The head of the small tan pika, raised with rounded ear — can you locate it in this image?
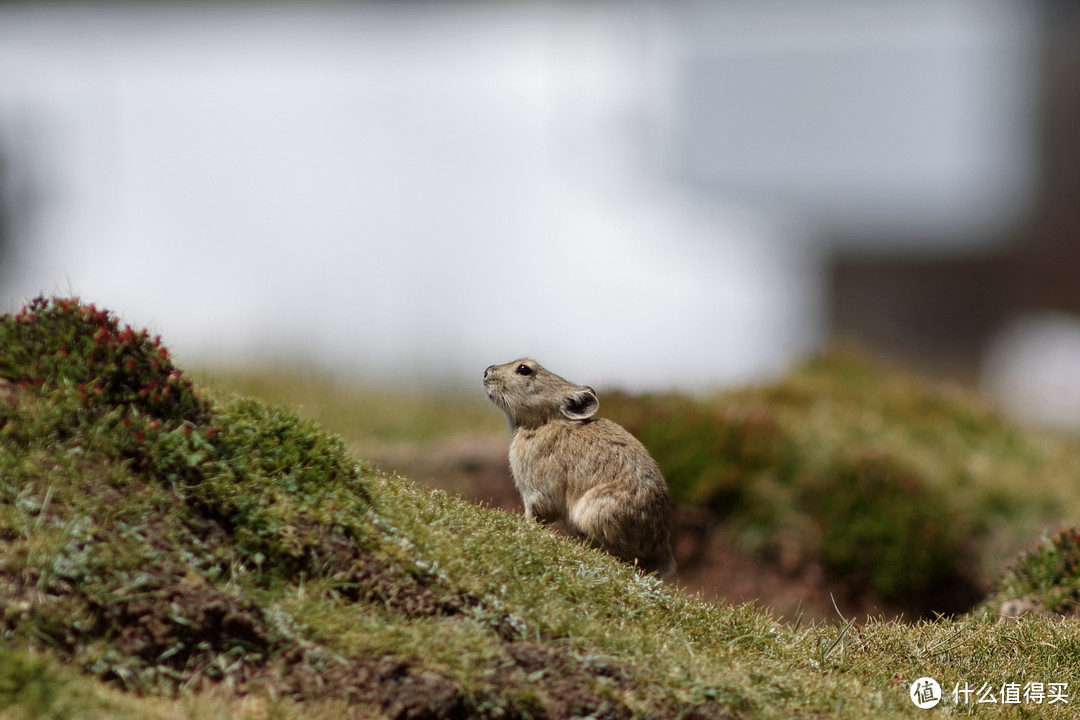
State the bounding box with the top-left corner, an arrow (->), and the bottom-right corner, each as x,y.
484,358 -> 600,429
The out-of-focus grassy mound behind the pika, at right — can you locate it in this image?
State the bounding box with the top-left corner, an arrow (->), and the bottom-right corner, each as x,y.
602,351 -> 1080,614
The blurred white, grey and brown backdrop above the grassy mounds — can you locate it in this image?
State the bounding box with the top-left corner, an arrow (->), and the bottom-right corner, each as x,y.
0,0 -> 1080,426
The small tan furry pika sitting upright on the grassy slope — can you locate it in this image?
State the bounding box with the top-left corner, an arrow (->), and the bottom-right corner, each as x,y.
484,358 -> 675,578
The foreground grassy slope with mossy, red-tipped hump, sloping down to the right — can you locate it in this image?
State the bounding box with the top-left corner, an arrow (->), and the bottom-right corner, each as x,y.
0,300 -> 1080,719
